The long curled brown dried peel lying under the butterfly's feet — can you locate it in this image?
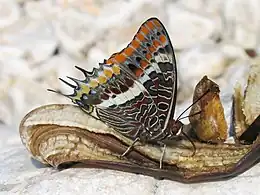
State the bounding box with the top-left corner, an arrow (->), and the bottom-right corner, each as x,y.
20,104 -> 260,183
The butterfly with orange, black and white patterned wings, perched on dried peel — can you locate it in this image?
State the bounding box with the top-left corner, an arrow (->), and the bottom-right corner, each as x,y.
49,18 -> 195,167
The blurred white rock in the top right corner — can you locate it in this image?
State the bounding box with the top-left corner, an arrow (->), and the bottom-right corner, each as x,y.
223,0 -> 260,48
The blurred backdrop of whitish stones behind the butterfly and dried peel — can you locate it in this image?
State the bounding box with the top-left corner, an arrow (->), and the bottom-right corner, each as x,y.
0,0 -> 260,133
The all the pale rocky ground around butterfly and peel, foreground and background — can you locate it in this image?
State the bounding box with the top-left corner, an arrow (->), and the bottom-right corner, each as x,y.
0,0 -> 260,194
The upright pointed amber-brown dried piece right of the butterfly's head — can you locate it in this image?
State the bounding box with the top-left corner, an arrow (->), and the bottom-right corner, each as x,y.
189,76 -> 228,143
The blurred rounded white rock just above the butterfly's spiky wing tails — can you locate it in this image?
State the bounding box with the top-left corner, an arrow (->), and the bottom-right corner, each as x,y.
54,9 -> 104,58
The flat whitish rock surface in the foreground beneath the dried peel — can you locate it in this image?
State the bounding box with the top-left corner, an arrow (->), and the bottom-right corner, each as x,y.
0,136 -> 260,195
